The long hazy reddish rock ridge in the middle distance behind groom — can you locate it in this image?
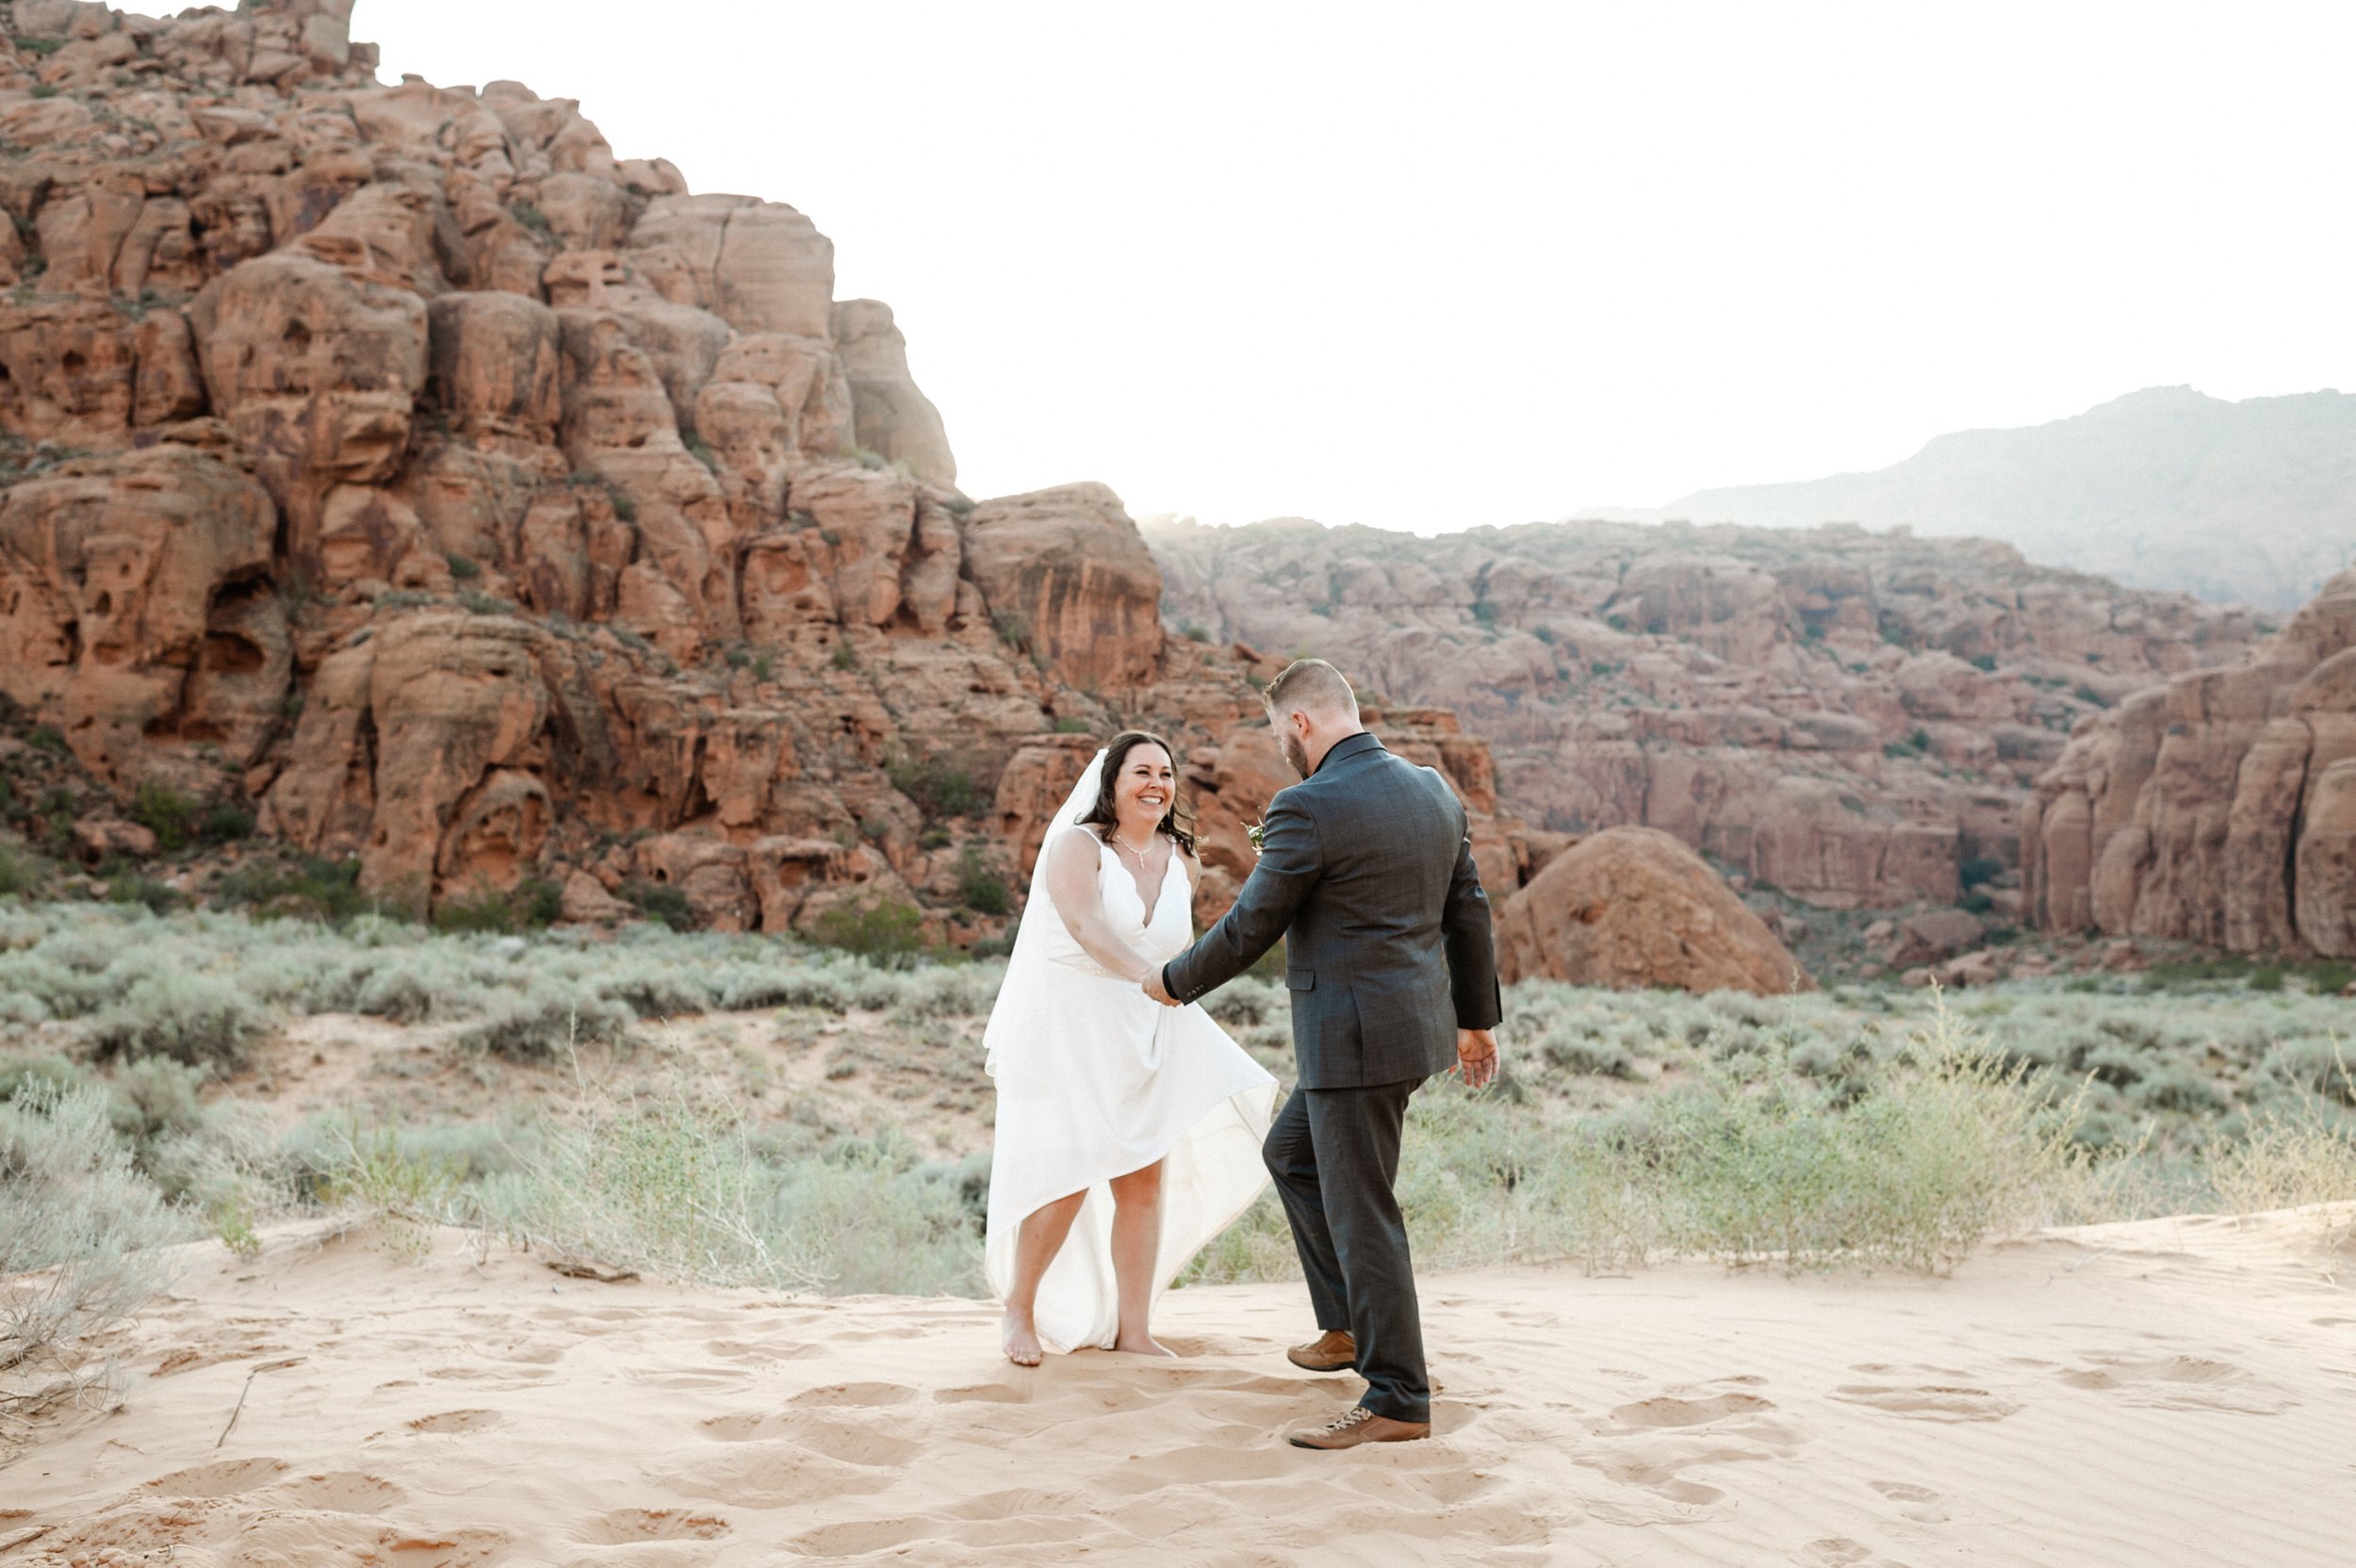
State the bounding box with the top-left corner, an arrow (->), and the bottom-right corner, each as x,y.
1148,506 -> 2252,906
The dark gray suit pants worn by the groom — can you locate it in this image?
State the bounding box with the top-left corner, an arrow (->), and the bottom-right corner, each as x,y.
1261,1078 -> 1432,1422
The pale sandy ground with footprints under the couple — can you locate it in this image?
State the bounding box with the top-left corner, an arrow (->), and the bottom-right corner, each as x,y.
0,1215 -> 2356,1568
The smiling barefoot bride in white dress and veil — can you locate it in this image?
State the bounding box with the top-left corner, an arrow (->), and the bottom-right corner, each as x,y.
983,730 -> 1277,1365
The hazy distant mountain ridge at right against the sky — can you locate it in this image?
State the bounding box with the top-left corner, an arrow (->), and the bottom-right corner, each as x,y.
1579,386 -> 2356,610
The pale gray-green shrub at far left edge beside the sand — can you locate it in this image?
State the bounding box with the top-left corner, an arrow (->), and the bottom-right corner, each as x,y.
0,1086 -> 187,1411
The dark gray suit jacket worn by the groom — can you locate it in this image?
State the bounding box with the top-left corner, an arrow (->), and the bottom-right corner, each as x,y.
1162,735 -> 1503,1087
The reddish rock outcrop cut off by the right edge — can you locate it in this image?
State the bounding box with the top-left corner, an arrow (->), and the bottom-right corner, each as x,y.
2021,572 -> 2356,958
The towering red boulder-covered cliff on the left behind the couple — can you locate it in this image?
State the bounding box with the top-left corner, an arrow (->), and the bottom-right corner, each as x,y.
0,0 -> 1520,939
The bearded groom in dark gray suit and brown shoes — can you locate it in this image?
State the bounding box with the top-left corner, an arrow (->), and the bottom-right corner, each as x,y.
1145,660 -> 1498,1448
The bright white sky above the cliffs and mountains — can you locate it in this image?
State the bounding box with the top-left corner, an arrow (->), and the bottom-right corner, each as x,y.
353,0 -> 2356,532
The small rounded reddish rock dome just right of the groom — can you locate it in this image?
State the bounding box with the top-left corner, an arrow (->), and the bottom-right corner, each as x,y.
1497,826 -> 1812,996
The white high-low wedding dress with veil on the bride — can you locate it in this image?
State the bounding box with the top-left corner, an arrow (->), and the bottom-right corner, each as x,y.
983,754 -> 1277,1351
